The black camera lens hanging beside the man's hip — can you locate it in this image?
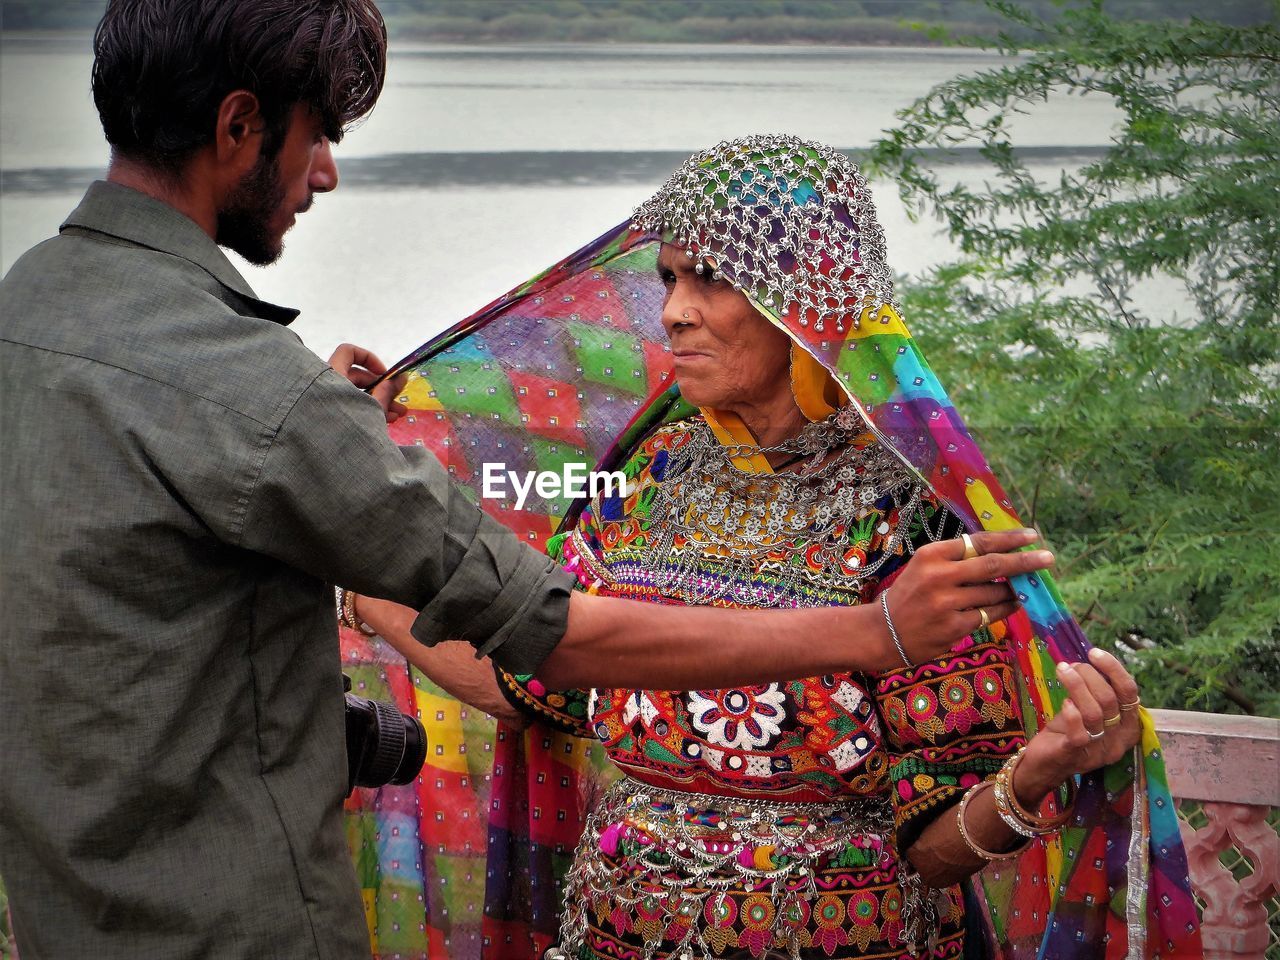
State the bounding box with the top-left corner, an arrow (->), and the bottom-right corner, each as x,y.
342,673 -> 426,794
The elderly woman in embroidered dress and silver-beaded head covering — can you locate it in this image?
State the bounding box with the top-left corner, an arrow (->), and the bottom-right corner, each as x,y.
348,137 -> 1187,960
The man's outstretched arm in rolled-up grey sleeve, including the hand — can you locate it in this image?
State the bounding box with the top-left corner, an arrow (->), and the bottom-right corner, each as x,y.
307,348 -> 1052,690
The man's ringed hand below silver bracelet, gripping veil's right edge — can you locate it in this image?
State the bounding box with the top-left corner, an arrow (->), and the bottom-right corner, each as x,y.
886,529 -> 1053,663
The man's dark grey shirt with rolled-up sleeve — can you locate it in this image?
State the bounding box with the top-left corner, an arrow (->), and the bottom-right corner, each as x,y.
0,183 -> 571,960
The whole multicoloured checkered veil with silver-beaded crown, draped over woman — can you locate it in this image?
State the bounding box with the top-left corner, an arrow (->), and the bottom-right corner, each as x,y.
344,137 -> 1201,960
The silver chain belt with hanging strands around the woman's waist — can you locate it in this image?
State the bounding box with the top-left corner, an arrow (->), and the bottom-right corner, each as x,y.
545,777 -> 932,960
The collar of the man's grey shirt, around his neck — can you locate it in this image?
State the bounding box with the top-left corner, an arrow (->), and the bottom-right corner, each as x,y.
60,180 -> 300,325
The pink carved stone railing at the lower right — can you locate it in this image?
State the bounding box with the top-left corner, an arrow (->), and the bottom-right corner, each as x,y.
1152,710 -> 1280,960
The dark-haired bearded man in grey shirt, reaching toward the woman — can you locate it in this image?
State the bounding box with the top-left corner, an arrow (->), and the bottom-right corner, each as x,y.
0,0 -> 1043,960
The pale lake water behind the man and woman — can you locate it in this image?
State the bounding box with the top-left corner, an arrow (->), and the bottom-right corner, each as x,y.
0,36 -> 1116,361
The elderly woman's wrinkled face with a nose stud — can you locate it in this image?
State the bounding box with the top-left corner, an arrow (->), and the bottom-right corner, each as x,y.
658,243 -> 794,412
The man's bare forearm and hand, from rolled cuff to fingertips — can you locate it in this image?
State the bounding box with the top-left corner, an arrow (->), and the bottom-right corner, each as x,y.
358,530 -> 1053,690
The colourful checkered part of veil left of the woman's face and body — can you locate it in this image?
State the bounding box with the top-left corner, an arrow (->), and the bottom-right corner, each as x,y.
342,224 -> 689,960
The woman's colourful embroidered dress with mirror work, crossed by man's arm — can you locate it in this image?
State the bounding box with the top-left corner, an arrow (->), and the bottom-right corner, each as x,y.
502,416 -> 1023,960
